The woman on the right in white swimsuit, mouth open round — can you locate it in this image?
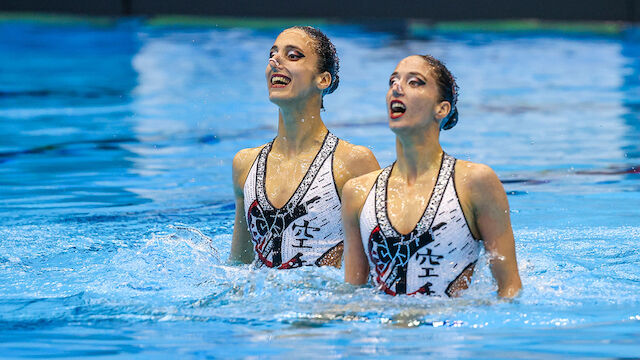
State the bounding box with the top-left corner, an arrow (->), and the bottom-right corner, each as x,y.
343,55 -> 521,297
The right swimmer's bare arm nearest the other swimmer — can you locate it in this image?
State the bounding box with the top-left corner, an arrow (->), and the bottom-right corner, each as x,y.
342,179 -> 369,285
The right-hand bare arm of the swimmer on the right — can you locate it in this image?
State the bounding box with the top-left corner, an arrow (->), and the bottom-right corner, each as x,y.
471,165 -> 522,298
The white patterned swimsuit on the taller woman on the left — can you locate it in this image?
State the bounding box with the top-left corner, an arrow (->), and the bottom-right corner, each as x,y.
244,133 -> 344,269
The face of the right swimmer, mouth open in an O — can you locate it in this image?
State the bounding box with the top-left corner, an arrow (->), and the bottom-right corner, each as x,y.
387,56 -> 451,132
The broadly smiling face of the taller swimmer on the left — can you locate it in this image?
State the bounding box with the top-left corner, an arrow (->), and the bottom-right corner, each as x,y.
265,29 -> 331,106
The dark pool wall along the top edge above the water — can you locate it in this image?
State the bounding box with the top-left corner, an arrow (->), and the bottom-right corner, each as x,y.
0,0 -> 640,22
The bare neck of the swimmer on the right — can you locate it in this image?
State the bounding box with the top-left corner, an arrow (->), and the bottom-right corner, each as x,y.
394,129 -> 442,186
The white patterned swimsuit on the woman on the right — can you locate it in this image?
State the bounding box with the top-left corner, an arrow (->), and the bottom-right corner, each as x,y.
360,154 -> 480,296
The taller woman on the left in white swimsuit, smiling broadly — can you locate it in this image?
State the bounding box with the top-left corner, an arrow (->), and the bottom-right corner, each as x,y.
231,26 -> 380,269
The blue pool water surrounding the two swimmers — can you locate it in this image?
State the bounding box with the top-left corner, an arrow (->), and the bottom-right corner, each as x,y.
0,19 -> 640,359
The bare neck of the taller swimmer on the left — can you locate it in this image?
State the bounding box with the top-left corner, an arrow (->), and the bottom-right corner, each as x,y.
273,106 -> 329,156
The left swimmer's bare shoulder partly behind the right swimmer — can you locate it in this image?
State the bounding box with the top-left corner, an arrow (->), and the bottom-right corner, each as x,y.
334,139 -> 380,182
